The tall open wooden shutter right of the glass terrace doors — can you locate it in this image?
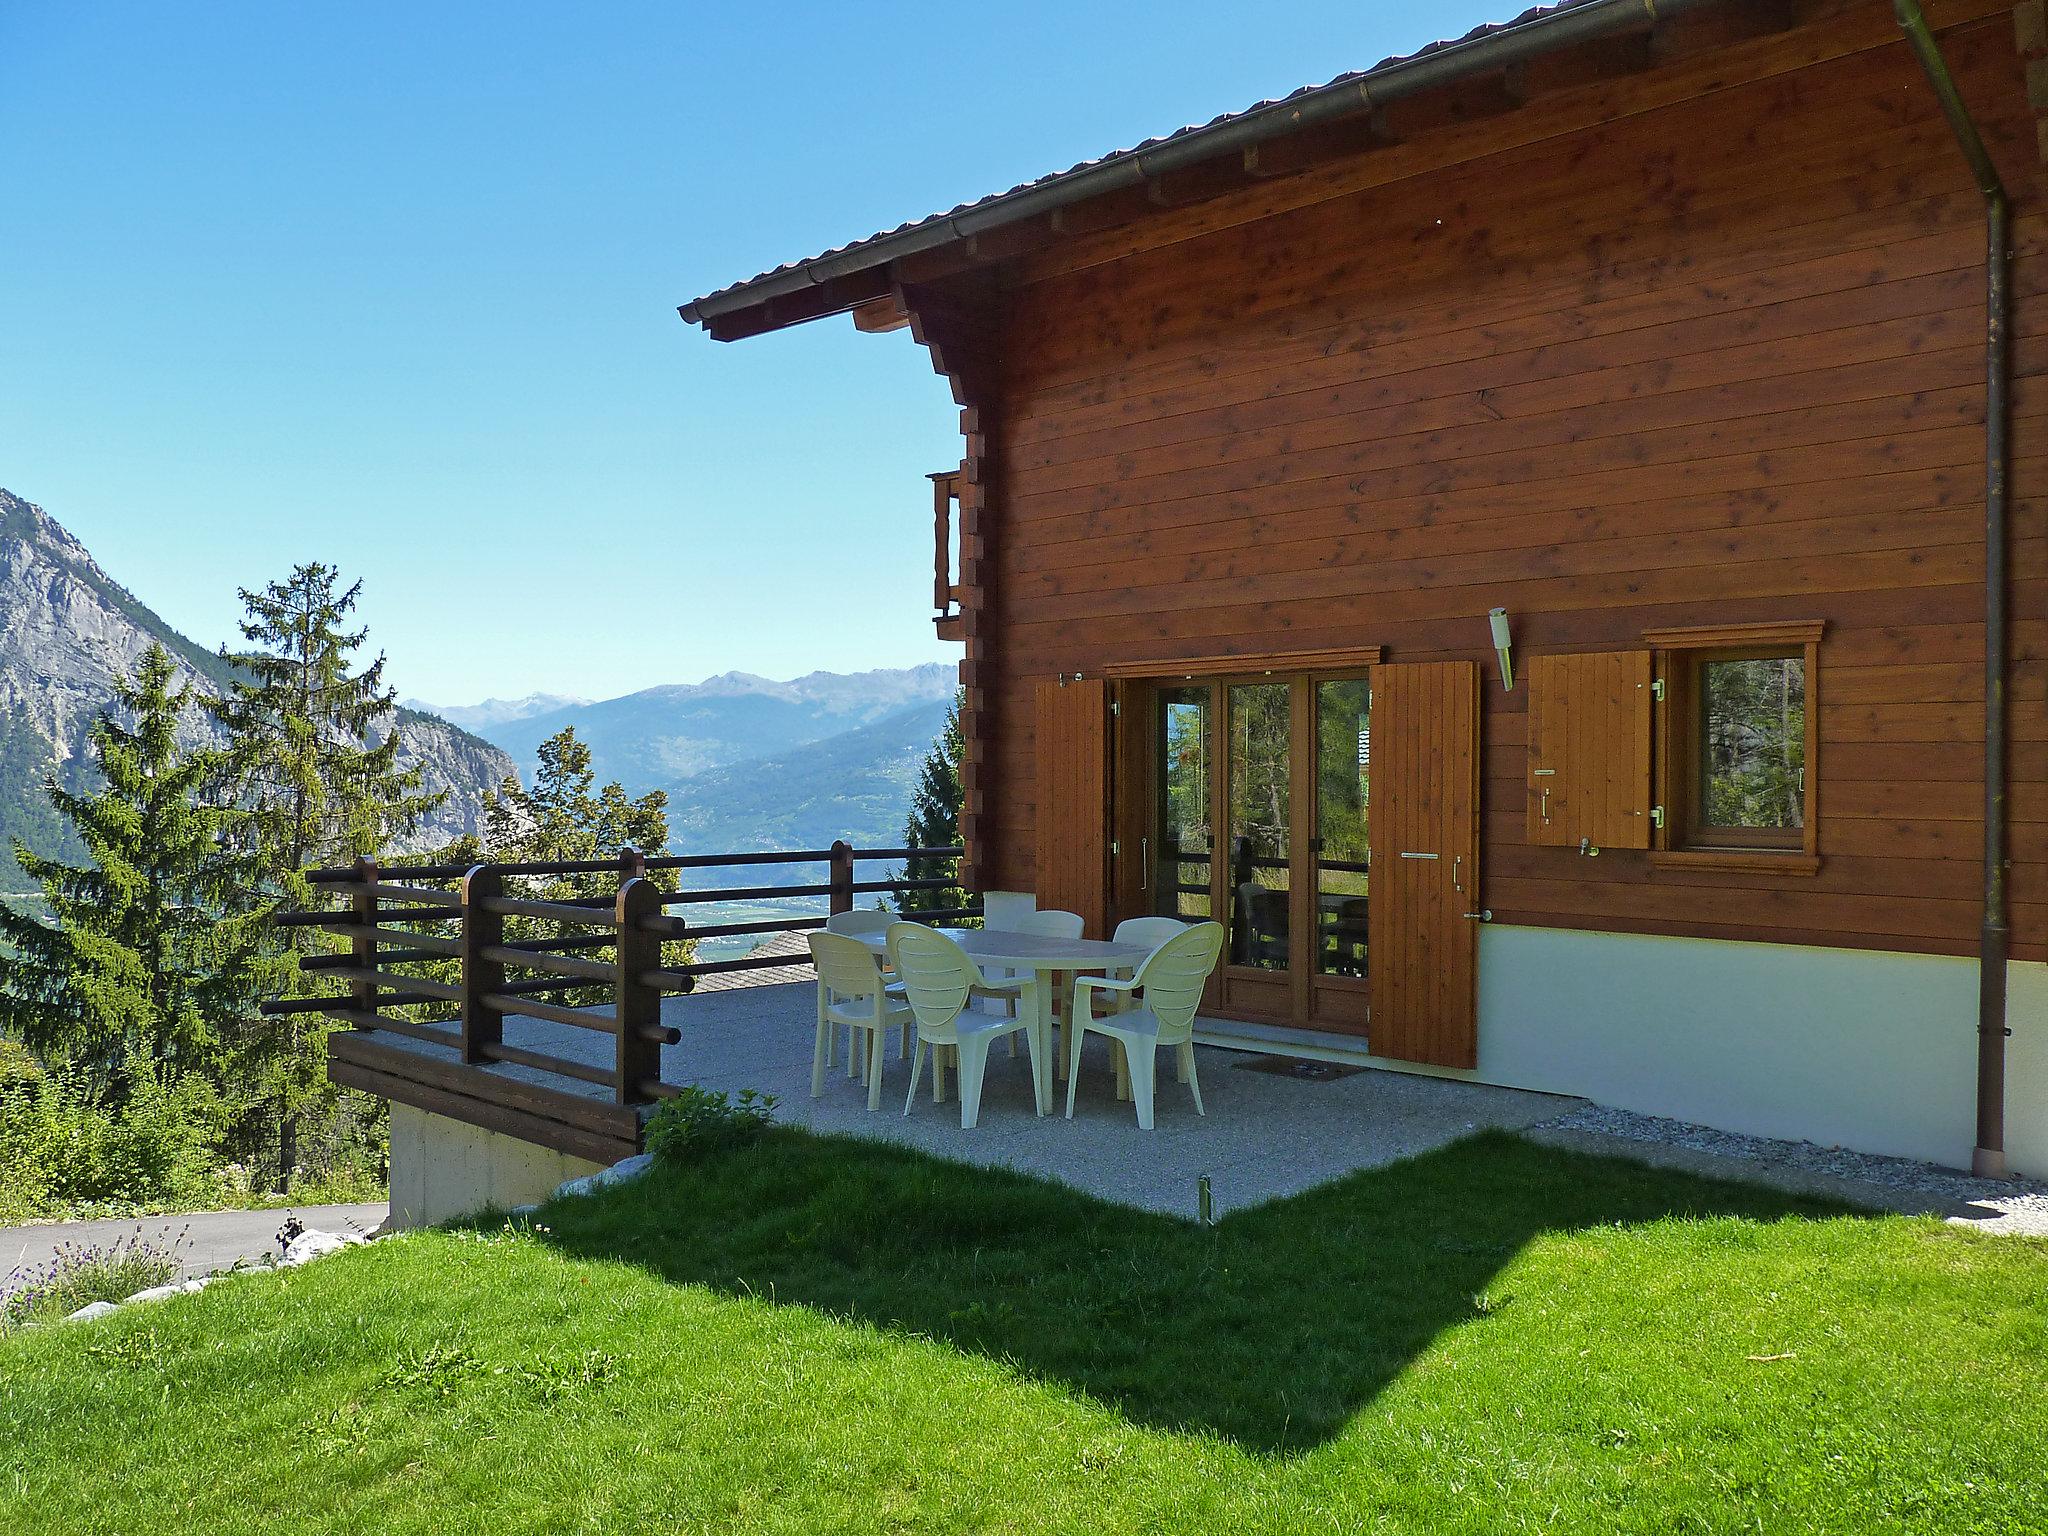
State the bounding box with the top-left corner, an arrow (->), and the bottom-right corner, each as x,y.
1366,662 -> 1479,1067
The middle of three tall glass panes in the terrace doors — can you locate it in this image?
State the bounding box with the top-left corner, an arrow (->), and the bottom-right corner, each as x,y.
1229,682 -> 1294,971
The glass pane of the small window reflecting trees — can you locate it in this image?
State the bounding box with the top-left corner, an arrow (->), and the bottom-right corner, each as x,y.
1700,655 -> 1806,831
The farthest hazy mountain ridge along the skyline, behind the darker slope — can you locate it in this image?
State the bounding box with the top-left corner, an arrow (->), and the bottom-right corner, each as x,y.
477,662 -> 956,786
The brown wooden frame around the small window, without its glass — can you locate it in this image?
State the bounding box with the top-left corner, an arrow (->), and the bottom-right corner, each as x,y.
1642,618 -> 1825,874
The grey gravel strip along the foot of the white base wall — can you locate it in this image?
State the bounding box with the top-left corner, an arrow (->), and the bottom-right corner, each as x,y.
1534,1104 -> 2048,1233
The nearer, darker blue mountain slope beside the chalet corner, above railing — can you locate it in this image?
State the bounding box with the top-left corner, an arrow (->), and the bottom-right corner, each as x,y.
668,696 -> 952,885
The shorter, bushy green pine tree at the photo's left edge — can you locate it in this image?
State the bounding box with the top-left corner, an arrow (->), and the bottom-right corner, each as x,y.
0,645 -> 268,1096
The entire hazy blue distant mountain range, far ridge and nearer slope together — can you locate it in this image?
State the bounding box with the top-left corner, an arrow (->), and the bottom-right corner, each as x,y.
438,662 -> 956,885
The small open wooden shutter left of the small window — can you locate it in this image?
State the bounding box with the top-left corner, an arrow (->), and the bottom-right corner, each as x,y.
1528,651 -> 1651,848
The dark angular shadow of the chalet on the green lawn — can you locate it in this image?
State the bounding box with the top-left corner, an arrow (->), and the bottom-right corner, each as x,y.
524,1128 -> 1851,1454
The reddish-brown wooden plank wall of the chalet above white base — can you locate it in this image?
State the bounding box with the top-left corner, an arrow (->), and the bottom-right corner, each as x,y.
975,4 -> 2048,958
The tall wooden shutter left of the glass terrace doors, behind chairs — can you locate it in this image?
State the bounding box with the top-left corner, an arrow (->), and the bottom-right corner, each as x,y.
1034,678 -> 1110,938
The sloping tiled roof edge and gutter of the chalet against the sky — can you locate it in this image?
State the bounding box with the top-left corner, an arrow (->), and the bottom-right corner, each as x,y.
680,0 -> 1708,324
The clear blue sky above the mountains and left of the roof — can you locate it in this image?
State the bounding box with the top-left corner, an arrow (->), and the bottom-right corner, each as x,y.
0,0 -> 1516,702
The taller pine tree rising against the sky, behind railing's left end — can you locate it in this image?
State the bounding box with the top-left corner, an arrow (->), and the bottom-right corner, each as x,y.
207,563 -> 444,1188
